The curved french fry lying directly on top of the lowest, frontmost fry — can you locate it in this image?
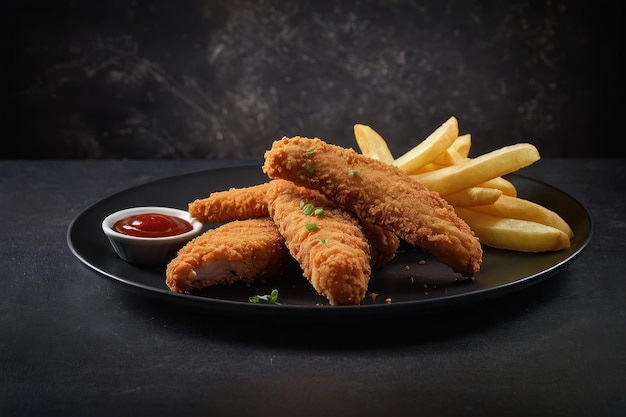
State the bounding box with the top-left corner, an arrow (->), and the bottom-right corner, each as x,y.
472,195 -> 574,239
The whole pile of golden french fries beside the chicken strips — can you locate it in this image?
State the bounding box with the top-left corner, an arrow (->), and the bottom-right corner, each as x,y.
354,117 -> 574,252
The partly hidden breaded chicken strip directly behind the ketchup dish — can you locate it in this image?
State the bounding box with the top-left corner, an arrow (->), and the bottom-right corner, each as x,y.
188,182 -> 269,223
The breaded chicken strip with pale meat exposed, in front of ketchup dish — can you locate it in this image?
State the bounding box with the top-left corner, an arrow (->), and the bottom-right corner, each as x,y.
165,217 -> 289,293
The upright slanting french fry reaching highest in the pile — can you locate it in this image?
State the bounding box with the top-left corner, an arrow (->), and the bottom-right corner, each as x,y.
393,116 -> 459,174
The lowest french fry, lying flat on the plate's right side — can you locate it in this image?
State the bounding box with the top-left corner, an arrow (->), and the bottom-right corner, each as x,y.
455,207 -> 570,252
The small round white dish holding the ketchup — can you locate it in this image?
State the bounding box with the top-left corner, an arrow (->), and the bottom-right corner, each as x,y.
102,206 -> 204,264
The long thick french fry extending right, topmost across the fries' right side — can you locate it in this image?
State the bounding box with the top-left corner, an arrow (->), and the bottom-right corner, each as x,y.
410,143 -> 540,195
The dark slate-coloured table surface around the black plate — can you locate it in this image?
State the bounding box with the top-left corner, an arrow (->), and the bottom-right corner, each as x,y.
0,159 -> 626,416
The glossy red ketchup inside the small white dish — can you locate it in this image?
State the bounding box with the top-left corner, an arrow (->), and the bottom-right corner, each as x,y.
113,213 -> 193,237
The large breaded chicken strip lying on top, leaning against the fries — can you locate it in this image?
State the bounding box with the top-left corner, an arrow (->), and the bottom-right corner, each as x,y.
263,137 -> 482,277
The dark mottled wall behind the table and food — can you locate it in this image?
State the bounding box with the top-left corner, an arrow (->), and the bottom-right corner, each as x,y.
0,0 -> 624,159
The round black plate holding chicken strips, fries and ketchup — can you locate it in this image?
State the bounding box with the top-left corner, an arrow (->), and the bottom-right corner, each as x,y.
67,165 -> 593,320
